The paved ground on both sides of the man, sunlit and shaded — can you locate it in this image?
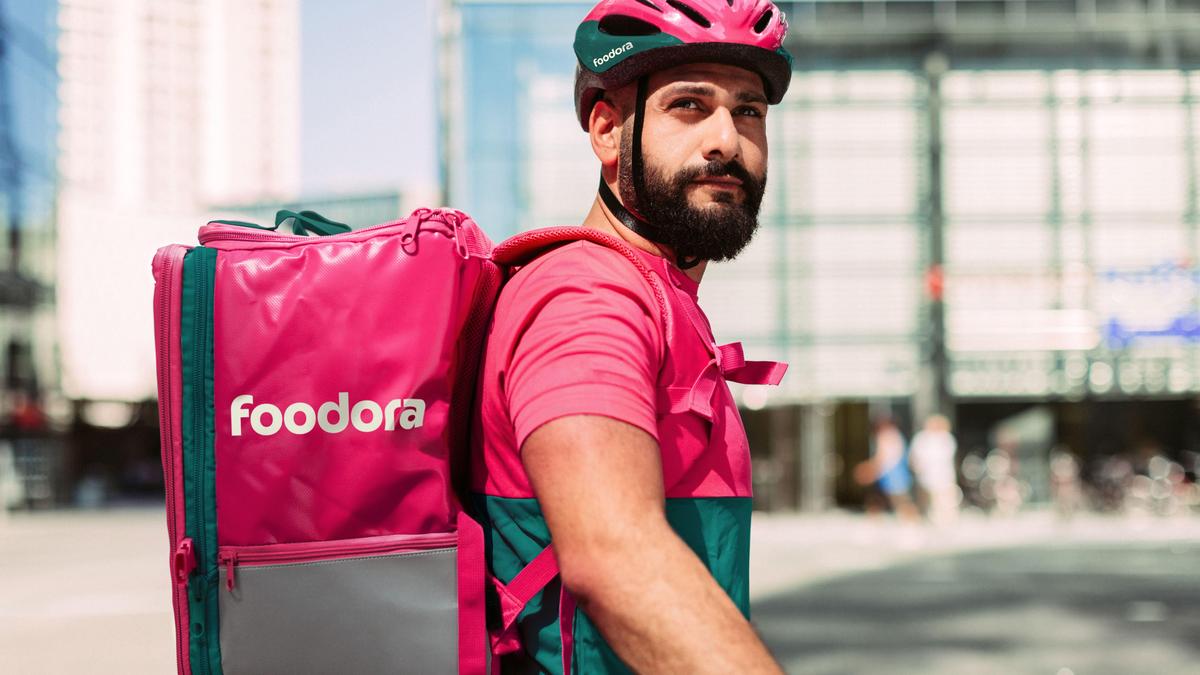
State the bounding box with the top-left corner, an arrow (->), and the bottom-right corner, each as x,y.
0,508 -> 1200,675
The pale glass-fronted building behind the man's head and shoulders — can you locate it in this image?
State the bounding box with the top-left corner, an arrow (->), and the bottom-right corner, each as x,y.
442,0 -> 1200,504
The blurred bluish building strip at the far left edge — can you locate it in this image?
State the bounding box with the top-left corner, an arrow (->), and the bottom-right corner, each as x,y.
0,0 -> 58,502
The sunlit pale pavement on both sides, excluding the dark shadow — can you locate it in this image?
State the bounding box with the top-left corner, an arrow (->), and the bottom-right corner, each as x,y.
0,508 -> 1200,675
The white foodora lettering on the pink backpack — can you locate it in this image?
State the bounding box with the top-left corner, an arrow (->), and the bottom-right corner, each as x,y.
229,392 -> 425,436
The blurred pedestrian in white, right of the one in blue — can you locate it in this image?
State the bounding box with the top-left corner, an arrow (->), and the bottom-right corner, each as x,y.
908,414 -> 962,525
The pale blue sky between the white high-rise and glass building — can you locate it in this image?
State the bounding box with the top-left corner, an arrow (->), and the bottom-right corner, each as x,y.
300,0 -> 438,196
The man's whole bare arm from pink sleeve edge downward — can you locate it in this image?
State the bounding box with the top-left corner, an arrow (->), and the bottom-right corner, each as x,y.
521,414 -> 780,674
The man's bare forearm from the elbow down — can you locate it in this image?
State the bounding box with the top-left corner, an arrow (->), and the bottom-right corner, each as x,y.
565,521 -> 780,674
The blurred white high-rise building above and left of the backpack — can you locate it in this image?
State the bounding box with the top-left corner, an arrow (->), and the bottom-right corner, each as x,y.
58,0 -> 300,401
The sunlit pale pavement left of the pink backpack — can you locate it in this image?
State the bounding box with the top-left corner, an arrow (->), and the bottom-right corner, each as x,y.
0,509 -> 175,675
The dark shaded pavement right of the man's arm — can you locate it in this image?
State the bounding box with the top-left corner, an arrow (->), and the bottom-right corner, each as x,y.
755,542 -> 1200,675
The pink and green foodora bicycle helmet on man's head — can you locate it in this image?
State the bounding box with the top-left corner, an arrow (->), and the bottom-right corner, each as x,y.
575,0 -> 792,131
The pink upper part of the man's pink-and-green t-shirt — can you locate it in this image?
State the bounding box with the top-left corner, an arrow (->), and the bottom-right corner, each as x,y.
472,241 -> 751,497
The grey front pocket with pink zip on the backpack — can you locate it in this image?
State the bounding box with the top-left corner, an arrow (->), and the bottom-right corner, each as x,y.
218,533 -> 458,675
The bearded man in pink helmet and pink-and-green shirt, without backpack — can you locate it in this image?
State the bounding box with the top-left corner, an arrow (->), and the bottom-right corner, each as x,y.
473,0 -> 791,674
